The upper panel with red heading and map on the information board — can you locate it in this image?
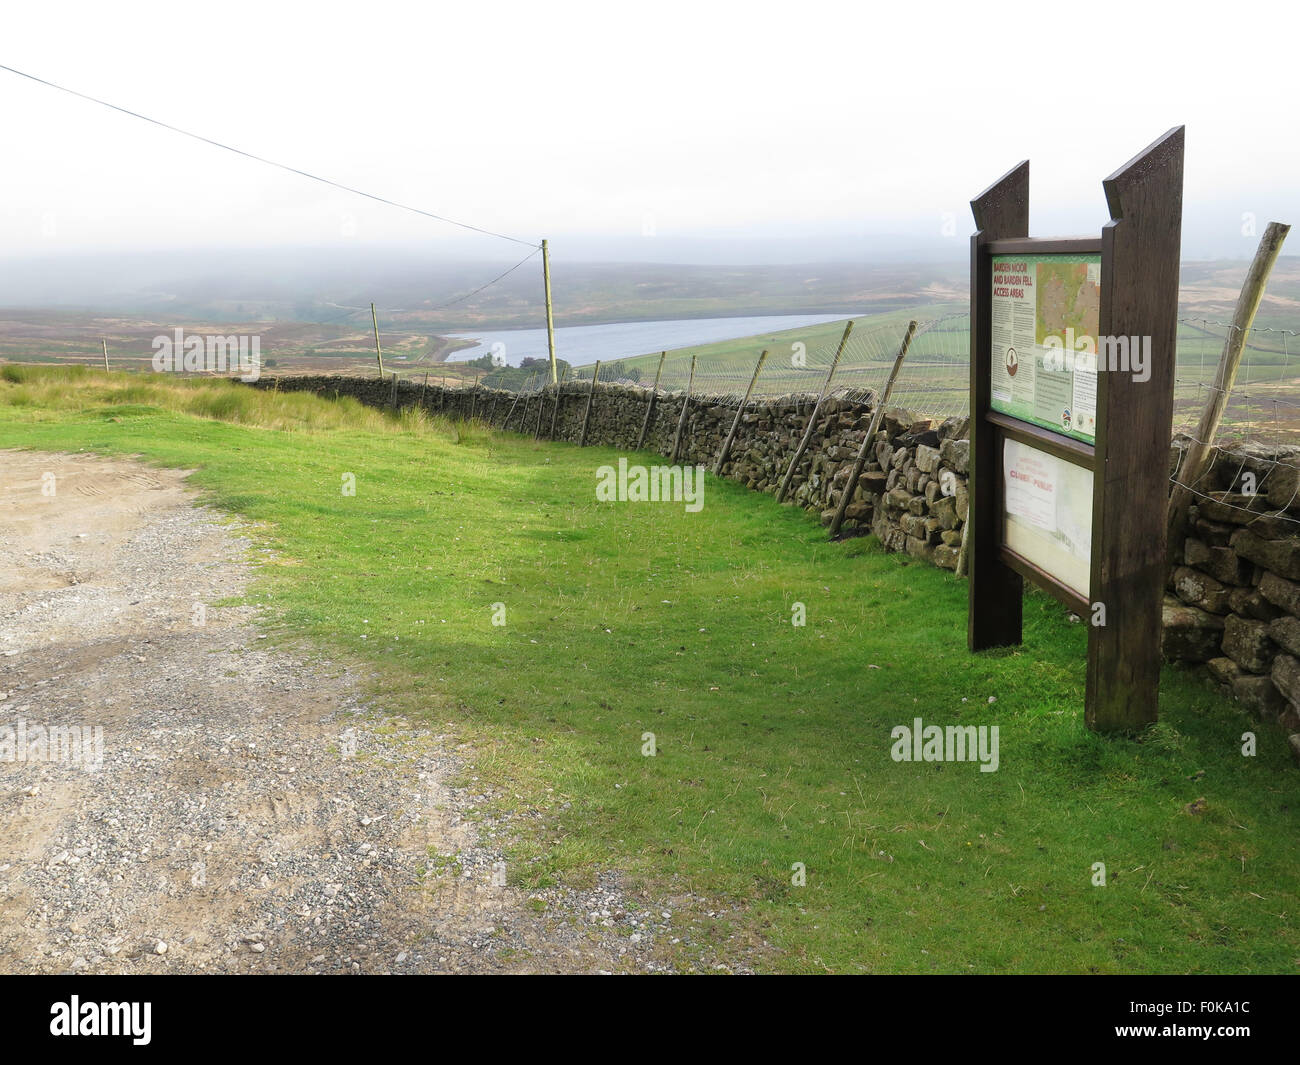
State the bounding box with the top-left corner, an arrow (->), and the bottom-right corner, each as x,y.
991,254 -> 1101,443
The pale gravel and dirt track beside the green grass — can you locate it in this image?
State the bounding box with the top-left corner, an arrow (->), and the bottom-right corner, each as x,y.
0,451 -> 698,973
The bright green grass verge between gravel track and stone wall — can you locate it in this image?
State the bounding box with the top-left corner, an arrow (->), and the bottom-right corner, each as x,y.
0,368 -> 1300,973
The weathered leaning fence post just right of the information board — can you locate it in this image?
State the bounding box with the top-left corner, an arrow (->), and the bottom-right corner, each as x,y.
1167,222 -> 1291,553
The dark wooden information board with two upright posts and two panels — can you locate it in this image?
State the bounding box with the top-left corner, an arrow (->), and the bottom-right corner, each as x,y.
967,126 -> 1183,732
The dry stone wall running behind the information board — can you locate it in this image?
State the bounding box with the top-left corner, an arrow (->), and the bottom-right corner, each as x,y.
248,377 -> 1300,756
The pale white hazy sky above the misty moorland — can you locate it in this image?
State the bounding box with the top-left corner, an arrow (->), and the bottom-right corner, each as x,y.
0,0 -> 1300,260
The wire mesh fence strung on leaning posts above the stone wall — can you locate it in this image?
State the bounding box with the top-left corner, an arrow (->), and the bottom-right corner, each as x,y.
462,311 -> 1300,534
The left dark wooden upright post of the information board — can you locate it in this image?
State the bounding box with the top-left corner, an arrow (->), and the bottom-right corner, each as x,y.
966,160 -> 1030,651
